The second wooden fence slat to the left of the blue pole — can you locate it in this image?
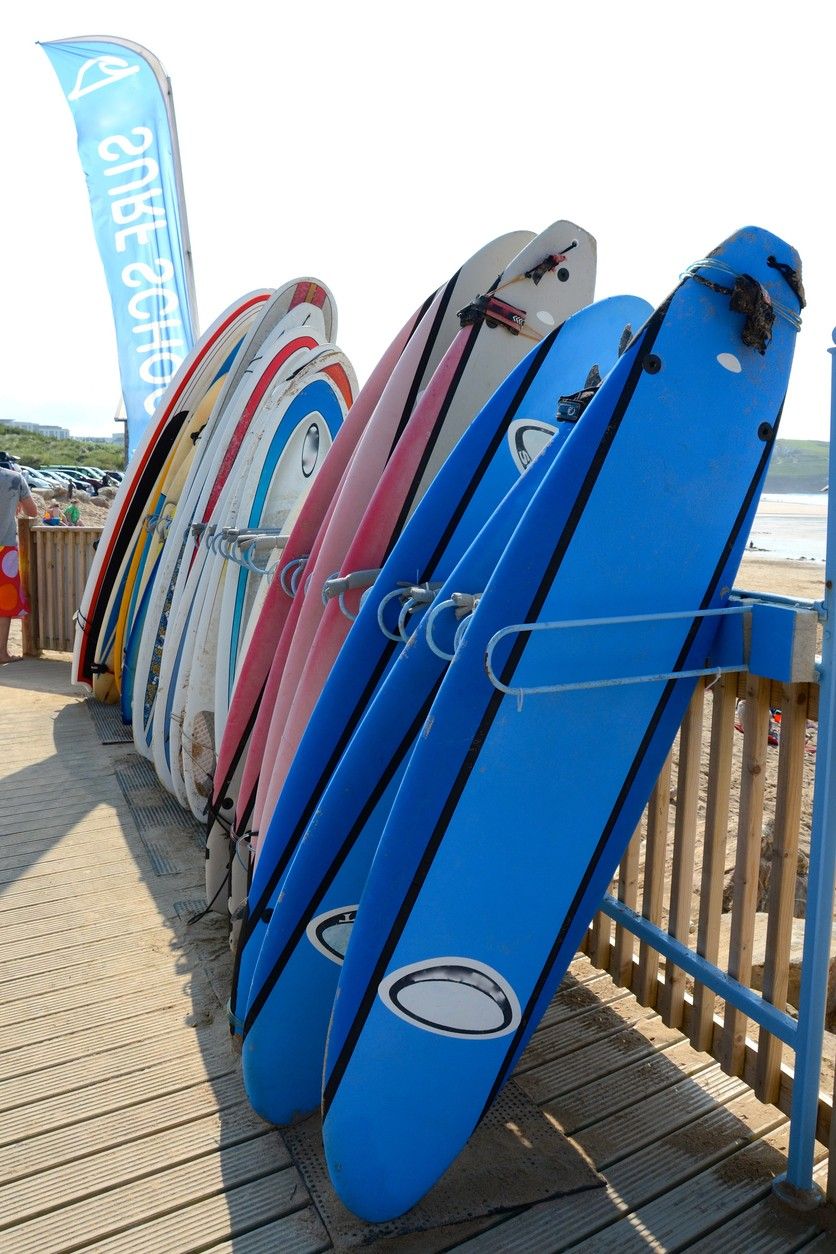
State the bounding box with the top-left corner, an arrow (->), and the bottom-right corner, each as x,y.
719,675 -> 770,1075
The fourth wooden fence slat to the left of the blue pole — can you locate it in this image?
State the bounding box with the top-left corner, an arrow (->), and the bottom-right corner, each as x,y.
662,683 -> 706,1027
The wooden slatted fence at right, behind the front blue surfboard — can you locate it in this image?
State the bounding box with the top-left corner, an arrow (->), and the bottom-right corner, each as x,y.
584,673 -> 836,1196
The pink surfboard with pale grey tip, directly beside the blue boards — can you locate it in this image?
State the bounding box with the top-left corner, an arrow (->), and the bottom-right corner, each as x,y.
253,222 -> 595,858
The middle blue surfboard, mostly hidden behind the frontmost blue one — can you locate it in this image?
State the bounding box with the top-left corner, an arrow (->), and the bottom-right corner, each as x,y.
242,428 -> 559,1124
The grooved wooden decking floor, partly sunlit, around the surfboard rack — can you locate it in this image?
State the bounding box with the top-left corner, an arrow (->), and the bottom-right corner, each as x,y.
0,661 -> 836,1254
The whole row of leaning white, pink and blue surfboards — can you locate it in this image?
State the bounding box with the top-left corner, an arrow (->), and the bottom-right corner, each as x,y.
73,221 -> 803,1220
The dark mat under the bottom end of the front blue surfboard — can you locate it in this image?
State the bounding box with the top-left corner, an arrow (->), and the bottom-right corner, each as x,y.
281,1080 -> 605,1254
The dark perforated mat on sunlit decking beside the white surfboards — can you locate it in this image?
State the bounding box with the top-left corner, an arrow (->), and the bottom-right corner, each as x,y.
114,754 -> 206,875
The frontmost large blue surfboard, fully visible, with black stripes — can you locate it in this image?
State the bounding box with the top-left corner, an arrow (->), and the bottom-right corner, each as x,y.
323,227 -> 802,1221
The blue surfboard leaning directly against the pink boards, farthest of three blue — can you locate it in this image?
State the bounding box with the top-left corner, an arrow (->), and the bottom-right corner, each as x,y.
231,296 -> 651,1053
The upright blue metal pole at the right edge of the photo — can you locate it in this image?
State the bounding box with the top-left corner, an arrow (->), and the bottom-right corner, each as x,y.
776,331 -> 836,1205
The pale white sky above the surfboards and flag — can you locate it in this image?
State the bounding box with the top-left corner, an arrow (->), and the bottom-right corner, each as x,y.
0,0 -> 836,439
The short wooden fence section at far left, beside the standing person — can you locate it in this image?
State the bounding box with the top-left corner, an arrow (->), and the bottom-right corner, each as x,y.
18,518 -> 102,657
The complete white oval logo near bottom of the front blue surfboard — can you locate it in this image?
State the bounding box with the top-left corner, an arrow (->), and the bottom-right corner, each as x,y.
377,958 -> 520,1040
